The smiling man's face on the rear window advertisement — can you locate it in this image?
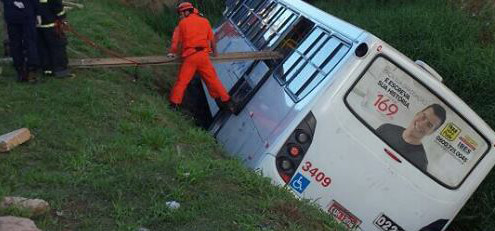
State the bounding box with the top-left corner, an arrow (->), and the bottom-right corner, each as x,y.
409,107 -> 442,138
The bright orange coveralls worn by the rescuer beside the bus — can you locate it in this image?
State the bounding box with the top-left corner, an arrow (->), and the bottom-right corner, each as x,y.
169,11 -> 230,105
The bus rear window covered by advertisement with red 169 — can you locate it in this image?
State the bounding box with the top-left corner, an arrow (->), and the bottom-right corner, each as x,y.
346,57 -> 489,188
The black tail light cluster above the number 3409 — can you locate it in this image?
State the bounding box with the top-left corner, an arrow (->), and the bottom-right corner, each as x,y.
275,112 -> 316,183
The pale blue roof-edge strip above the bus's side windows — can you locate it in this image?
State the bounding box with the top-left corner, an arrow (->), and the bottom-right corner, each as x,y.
279,0 -> 365,41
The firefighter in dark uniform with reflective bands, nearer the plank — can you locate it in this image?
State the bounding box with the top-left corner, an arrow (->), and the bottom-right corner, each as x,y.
36,0 -> 73,78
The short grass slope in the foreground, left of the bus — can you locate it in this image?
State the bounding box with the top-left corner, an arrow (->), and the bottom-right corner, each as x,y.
0,1 -> 344,231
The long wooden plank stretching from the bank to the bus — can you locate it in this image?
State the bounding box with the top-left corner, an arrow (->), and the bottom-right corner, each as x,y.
69,51 -> 283,68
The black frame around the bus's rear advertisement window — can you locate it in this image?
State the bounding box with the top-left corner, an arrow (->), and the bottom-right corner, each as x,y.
342,54 -> 491,190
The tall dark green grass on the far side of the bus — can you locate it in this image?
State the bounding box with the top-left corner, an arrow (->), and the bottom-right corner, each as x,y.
316,0 -> 495,230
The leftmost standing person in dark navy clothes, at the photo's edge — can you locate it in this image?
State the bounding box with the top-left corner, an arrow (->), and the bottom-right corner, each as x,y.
0,0 -> 39,82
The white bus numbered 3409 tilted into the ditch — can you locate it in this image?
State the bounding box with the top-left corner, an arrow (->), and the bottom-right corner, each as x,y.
198,0 -> 495,231
